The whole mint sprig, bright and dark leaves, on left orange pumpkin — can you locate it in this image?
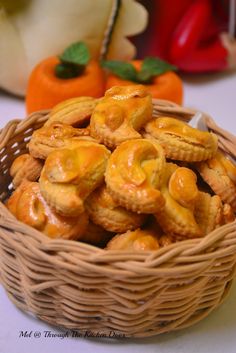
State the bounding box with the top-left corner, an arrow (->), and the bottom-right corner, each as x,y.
55,42 -> 90,79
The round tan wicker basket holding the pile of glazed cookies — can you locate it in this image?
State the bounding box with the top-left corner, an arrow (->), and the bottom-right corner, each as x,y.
0,100 -> 236,337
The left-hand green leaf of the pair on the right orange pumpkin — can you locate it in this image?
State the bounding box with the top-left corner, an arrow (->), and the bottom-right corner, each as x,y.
101,60 -> 137,82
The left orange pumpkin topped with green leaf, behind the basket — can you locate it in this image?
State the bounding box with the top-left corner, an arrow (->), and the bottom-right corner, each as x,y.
26,42 -> 105,113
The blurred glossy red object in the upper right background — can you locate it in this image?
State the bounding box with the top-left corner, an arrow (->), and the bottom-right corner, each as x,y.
135,0 -> 236,72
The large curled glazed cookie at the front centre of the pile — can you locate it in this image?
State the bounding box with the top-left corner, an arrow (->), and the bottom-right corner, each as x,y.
105,139 -> 166,213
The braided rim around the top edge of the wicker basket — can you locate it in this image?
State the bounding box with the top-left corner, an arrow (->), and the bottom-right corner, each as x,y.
0,99 -> 236,263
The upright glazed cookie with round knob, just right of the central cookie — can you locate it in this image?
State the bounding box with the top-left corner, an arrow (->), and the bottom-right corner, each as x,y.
155,163 -> 203,238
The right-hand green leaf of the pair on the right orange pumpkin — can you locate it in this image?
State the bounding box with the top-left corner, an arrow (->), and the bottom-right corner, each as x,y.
138,57 -> 177,83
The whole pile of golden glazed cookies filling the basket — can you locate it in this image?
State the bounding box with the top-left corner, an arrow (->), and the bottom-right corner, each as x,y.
6,85 -> 236,251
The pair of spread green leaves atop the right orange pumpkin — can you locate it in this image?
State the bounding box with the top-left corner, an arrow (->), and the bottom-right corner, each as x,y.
101,57 -> 177,84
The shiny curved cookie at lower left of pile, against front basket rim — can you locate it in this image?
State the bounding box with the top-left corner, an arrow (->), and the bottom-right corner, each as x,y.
6,180 -> 88,240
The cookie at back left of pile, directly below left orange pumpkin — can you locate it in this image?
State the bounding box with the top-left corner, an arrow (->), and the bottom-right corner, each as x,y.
44,97 -> 98,127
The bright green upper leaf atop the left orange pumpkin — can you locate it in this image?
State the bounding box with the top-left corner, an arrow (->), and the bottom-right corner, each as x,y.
59,42 -> 90,66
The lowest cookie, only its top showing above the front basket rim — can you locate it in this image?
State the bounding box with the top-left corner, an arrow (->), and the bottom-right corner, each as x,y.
106,229 -> 160,251
